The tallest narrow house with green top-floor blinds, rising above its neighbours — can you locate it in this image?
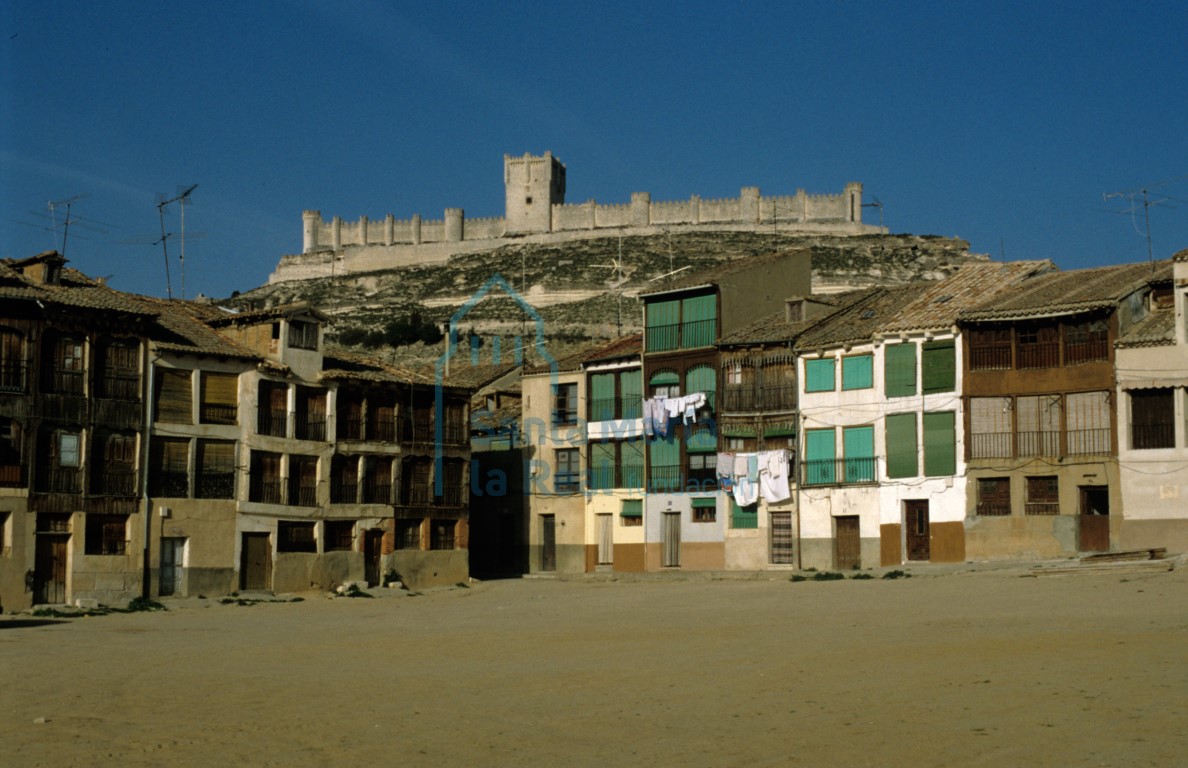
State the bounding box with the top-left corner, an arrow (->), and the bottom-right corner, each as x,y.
640,251 -> 811,569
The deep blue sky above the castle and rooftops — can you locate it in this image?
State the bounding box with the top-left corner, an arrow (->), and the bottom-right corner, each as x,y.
0,0 -> 1188,297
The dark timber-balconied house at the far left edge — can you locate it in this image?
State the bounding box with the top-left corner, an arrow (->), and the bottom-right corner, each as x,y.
0,251 -> 153,610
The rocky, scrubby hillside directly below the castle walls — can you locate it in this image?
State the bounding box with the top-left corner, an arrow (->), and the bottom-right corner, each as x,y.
228,232 -> 986,366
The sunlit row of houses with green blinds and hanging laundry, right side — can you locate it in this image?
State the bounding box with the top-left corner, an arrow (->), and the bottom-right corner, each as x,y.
523,251 -> 1188,572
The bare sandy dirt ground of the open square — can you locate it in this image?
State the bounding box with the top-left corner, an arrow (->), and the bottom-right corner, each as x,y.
0,566 -> 1188,768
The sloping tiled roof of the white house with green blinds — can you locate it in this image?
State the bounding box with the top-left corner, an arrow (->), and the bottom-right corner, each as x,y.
879,260 -> 1056,333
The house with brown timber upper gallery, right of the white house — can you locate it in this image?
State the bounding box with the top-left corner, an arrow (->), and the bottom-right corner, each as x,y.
959,262 -> 1175,559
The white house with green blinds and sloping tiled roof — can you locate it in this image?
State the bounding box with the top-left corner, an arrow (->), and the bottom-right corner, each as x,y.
795,262 -> 1051,569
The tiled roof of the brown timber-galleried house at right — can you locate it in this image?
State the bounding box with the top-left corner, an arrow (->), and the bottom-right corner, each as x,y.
958,262 -> 1171,321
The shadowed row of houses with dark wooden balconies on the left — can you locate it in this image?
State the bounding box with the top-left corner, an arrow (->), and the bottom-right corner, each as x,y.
0,252 -> 470,610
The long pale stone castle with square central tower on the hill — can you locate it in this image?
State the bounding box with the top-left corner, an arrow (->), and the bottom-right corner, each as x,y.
268,152 -> 886,284
